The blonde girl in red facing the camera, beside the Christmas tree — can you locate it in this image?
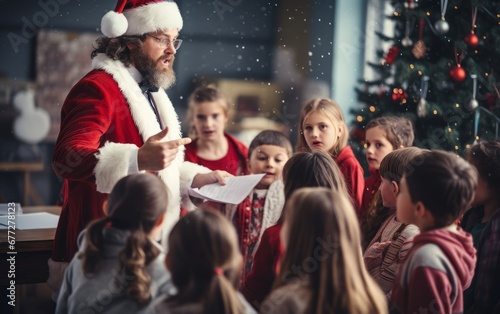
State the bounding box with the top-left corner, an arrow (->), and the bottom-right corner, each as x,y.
297,98 -> 365,212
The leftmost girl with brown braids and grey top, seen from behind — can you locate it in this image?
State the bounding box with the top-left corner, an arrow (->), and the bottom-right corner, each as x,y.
56,173 -> 172,313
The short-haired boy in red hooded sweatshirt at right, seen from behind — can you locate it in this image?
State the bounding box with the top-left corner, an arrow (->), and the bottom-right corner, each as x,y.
391,151 -> 477,313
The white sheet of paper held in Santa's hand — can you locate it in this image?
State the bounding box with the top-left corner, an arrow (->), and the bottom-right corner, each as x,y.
189,173 -> 266,204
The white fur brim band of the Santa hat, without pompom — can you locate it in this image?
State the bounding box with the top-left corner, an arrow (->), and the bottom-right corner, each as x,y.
123,1 -> 183,35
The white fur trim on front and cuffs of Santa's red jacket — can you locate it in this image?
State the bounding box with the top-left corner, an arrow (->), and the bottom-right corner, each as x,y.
92,54 -> 210,245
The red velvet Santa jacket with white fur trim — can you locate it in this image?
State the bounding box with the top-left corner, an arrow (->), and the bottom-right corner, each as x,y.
52,54 -> 210,262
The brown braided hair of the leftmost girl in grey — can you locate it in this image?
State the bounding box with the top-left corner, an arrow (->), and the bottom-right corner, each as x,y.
79,173 -> 168,305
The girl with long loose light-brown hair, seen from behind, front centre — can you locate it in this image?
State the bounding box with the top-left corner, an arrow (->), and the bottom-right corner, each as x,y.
261,187 -> 387,314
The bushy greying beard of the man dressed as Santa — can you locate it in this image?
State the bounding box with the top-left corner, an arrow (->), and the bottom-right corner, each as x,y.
131,49 -> 175,89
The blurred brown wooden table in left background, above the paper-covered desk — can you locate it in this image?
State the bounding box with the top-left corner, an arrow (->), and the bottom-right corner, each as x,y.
0,161 -> 43,206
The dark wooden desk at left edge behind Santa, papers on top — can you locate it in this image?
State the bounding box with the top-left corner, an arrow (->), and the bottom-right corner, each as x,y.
0,206 -> 61,286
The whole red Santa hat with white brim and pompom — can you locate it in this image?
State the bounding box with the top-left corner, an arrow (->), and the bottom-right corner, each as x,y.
101,0 -> 182,37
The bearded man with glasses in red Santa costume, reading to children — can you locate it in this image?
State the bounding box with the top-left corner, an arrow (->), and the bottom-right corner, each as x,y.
48,0 -> 229,300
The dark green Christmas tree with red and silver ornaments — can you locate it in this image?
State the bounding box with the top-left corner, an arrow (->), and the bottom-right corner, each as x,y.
351,0 -> 500,167
